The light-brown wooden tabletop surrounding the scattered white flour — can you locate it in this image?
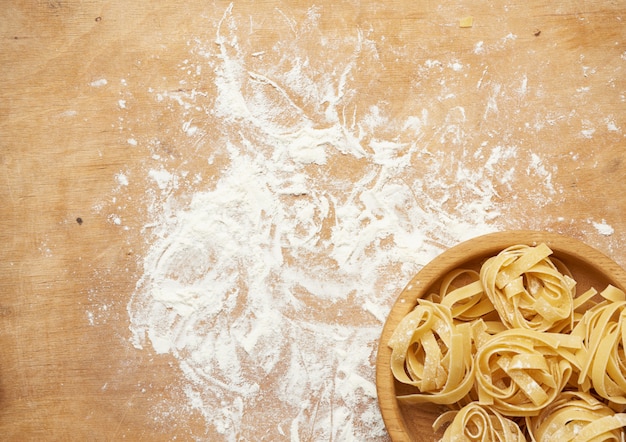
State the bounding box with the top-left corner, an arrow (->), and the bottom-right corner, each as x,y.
0,0 -> 626,440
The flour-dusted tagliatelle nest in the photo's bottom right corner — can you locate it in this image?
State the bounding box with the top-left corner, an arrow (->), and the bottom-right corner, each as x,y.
526,391 -> 626,442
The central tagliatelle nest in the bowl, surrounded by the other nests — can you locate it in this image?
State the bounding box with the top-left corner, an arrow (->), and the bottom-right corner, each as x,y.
475,329 -> 582,416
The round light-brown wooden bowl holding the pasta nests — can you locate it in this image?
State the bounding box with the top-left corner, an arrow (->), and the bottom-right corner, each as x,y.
376,231 -> 626,442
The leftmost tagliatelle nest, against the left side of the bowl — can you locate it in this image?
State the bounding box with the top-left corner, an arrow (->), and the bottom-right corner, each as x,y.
389,299 -> 474,404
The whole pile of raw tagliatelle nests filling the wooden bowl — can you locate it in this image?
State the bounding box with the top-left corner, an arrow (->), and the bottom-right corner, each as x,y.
389,244 -> 626,442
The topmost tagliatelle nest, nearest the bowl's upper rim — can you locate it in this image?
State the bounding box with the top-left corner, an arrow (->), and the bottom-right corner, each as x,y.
480,244 -> 576,332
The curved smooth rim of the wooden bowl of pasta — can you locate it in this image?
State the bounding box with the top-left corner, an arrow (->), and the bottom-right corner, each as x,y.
376,230 -> 626,442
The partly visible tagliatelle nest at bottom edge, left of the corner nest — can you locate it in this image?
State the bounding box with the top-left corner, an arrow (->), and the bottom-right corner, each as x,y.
433,402 -> 526,442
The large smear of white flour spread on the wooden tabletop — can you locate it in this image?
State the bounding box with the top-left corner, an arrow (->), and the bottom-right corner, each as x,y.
123,6 -> 560,441
